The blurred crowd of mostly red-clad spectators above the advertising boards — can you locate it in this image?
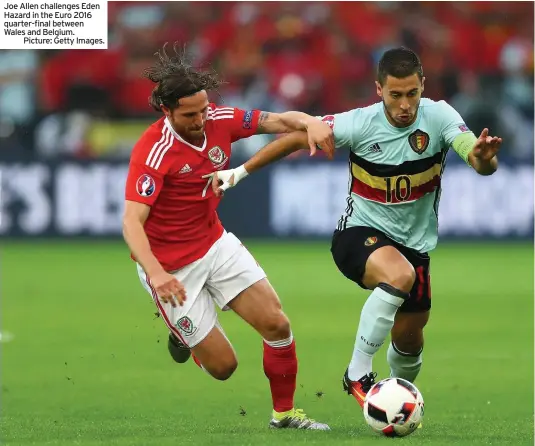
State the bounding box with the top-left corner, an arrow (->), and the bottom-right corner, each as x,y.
0,1 -> 534,163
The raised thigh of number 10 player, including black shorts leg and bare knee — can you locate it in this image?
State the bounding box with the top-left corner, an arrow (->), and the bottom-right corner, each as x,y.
331,226 -> 415,293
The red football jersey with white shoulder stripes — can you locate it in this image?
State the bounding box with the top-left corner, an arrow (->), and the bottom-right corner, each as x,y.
126,104 -> 260,271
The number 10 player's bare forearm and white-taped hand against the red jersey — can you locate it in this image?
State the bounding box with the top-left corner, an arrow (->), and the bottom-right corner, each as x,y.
203,132 -> 312,196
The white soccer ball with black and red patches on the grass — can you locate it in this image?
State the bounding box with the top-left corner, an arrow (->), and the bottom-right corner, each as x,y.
364,378 -> 424,437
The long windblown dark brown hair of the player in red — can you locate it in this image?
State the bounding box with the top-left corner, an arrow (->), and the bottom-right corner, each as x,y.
143,42 -> 223,111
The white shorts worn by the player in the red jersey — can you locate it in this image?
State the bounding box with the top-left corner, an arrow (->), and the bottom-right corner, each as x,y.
137,232 -> 266,348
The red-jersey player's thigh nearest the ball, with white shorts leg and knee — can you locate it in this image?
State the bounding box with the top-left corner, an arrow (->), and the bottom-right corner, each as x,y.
207,233 -> 289,340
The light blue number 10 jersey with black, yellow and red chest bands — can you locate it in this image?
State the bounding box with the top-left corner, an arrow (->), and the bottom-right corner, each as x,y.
322,98 -> 470,252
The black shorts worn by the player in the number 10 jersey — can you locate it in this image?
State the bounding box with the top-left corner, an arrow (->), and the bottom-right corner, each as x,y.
331,226 -> 431,312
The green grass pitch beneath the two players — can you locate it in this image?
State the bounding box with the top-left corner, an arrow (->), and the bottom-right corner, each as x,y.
0,242 -> 533,446
